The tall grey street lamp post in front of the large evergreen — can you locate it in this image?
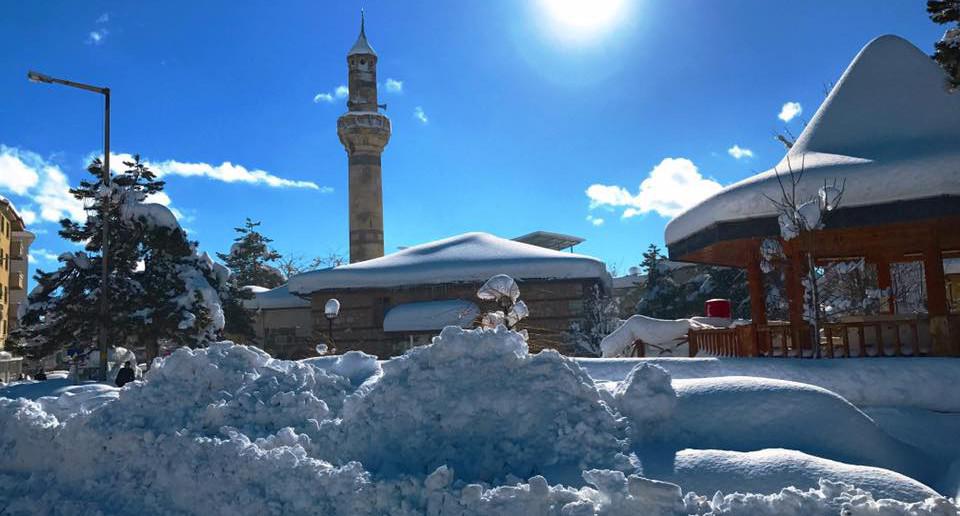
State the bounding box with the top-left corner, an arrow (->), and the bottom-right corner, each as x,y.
27,70 -> 110,381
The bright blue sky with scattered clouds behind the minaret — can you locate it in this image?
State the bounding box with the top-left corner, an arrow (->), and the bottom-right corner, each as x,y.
0,0 -> 943,282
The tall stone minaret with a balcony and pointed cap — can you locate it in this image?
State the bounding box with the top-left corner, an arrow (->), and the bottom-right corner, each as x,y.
337,11 -> 390,263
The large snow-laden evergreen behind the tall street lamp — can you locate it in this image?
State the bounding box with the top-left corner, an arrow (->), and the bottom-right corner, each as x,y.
15,157 -> 224,358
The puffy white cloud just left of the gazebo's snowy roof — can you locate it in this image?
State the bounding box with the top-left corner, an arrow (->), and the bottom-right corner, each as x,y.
586,158 -> 722,219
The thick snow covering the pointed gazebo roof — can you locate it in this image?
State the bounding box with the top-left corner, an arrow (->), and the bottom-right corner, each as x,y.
665,36 -> 960,245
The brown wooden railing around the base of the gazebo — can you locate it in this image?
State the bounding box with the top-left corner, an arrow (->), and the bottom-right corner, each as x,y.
688,318 -> 931,358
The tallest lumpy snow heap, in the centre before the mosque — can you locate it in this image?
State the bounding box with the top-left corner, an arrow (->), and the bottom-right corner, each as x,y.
315,326 -> 626,482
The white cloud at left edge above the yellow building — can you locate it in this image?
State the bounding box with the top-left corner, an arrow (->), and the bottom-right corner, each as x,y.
0,145 -> 87,224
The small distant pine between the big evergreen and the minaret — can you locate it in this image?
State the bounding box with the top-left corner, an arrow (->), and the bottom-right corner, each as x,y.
217,218 -> 286,288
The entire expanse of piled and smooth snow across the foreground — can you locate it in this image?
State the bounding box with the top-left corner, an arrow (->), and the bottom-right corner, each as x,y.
0,327 -> 960,516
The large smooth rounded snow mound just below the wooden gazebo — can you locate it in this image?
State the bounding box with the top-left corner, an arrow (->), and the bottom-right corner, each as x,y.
668,376 -> 946,482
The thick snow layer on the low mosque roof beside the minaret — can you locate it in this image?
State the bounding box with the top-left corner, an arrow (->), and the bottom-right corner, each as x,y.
290,233 -> 608,294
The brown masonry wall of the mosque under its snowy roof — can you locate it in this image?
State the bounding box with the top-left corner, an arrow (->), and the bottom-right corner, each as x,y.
312,280 -> 597,358
